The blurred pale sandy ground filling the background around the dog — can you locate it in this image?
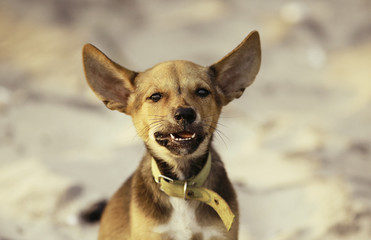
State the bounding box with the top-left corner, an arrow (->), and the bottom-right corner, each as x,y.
0,0 -> 371,240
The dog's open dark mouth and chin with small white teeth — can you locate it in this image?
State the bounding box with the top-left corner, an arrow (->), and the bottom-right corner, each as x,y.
154,131 -> 205,156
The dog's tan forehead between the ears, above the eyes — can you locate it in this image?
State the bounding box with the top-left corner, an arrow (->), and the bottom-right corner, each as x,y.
141,60 -> 211,86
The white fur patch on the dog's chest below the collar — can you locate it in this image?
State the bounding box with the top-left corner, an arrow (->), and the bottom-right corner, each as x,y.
154,197 -> 224,240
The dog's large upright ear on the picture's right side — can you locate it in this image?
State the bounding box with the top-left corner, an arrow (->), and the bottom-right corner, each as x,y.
210,31 -> 261,105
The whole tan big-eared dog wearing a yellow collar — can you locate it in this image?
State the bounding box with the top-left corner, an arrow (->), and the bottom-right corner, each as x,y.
83,31 -> 261,240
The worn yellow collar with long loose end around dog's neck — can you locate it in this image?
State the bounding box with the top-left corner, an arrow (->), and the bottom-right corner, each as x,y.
151,153 -> 235,231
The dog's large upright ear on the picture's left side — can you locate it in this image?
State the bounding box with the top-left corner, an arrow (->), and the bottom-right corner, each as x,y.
82,44 -> 137,114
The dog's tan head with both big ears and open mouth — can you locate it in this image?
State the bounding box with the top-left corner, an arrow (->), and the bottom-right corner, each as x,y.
83,32 -> 261,165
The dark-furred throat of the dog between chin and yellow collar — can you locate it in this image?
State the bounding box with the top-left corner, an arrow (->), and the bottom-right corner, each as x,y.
153,152 -> 209,180
